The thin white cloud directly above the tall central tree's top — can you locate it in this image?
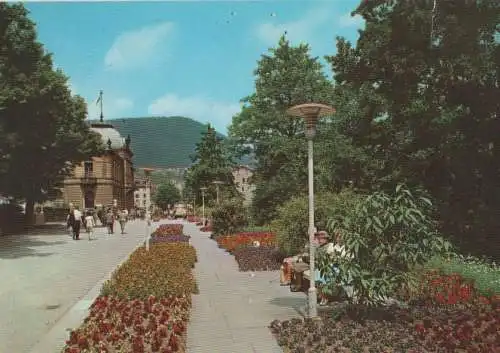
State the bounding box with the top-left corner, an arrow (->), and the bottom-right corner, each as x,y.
255,6 -> 332,46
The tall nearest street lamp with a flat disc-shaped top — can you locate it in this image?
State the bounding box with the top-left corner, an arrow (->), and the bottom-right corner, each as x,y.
287,103 -> 335,318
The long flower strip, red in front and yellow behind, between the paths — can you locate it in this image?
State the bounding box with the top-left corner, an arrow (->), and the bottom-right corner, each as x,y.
63,243 -> 197,353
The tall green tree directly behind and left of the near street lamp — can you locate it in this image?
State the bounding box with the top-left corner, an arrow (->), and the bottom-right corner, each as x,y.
229,36 -> 331,223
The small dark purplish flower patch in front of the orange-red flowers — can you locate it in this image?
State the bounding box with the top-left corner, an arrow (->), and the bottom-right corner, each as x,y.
233,246 -> 284,271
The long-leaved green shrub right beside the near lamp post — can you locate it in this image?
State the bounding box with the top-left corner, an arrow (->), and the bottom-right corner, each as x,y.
318,185 -> 449,304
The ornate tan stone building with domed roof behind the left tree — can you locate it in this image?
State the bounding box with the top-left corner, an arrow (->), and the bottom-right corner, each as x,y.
63,117 -> 135,209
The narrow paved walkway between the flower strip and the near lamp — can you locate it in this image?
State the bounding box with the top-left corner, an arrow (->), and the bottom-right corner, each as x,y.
184,223 -> 300,353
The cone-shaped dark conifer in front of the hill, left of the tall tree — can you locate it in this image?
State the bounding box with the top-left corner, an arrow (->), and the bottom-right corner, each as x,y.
185,125 -> 237,202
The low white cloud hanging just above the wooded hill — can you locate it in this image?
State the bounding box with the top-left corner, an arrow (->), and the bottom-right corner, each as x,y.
148,94 -> 241,133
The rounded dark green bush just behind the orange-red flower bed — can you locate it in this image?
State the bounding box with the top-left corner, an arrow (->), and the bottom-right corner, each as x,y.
212,200 -> 247,236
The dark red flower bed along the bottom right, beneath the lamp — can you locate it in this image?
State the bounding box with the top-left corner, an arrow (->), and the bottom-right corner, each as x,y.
270,273 -> 500,353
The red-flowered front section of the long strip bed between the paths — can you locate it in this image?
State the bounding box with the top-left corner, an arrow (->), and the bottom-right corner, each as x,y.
64,296 -> 191,353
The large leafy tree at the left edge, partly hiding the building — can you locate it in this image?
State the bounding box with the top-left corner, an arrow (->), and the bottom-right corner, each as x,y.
0,3 -> 103,221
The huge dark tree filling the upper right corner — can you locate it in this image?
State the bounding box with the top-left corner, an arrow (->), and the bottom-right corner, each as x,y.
329,0 -> 500,256
